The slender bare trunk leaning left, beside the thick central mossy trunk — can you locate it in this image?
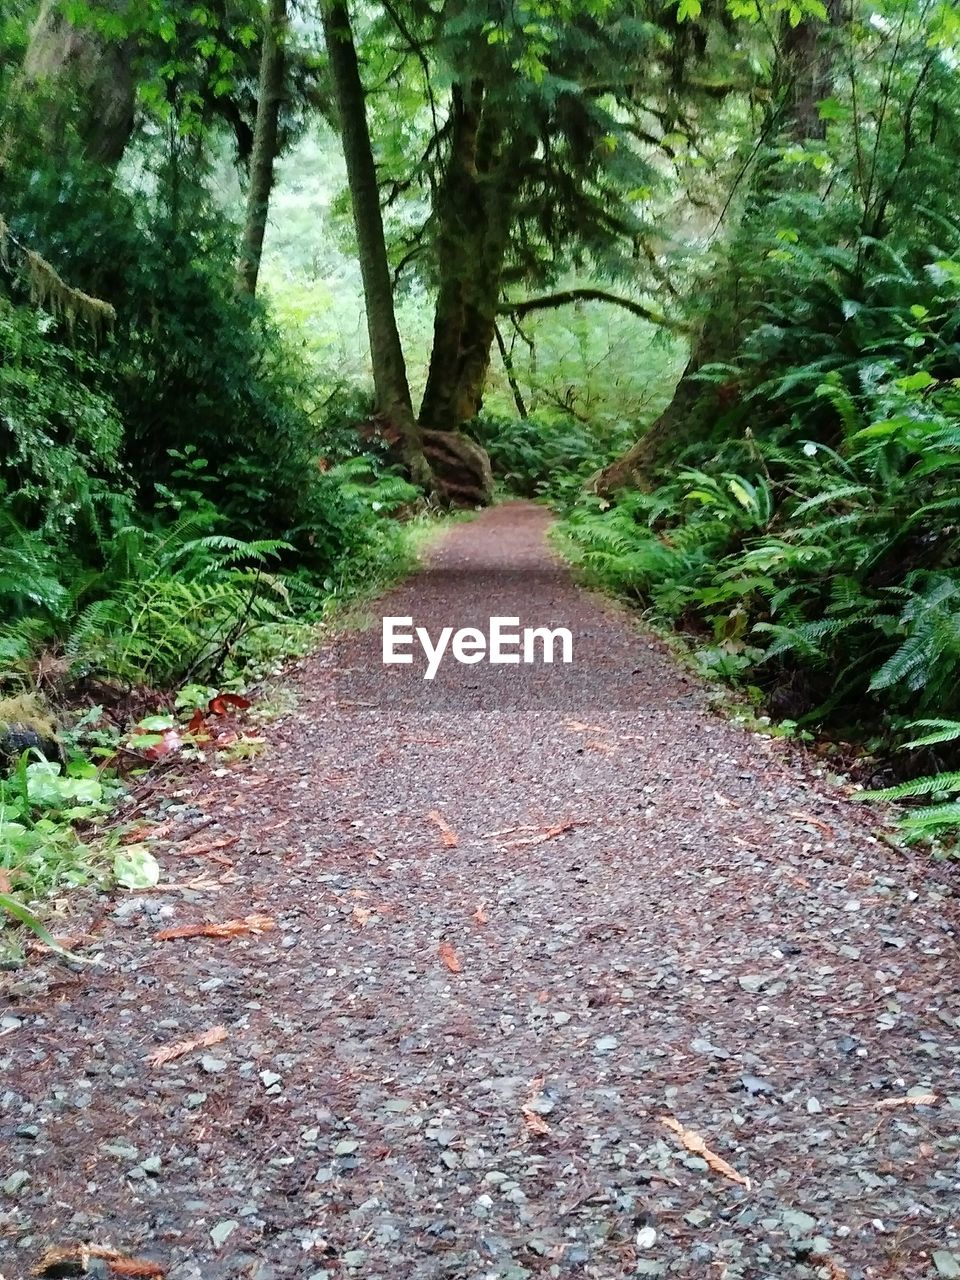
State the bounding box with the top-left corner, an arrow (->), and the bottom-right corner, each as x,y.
320,0 -> 436,490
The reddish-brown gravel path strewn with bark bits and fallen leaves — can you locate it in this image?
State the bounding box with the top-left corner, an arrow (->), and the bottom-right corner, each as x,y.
0,503 -> 960,1280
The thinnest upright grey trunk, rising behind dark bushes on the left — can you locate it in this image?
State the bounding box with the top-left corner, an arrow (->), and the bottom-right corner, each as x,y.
237,0 -> 287,297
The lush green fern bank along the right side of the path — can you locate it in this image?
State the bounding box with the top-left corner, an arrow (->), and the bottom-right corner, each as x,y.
567,307 -> 960,742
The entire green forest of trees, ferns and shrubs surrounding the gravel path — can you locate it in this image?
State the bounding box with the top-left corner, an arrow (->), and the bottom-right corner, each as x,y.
0,0 -> 960,957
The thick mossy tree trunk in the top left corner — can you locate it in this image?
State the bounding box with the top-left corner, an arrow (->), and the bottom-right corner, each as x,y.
4,0 -> 137,166
